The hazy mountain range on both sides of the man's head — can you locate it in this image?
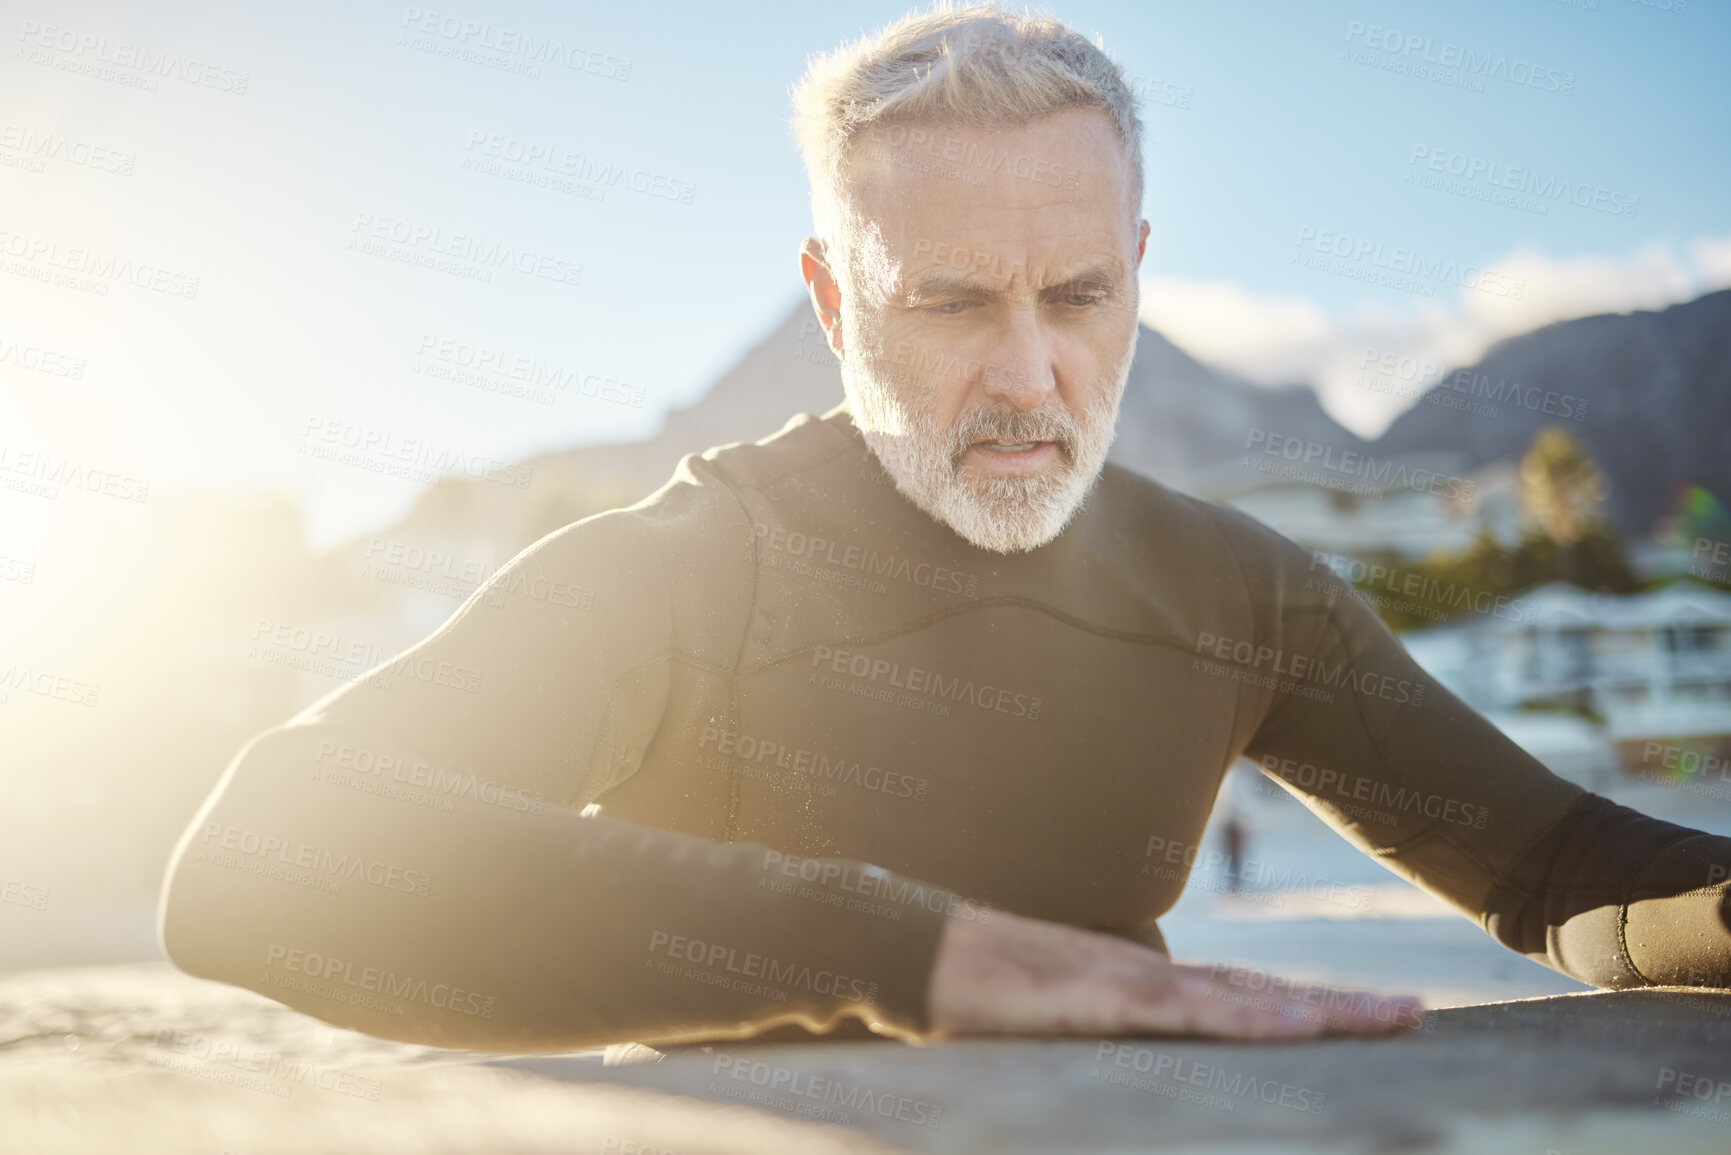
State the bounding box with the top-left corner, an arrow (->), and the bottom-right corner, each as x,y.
354,291 -> 1731,565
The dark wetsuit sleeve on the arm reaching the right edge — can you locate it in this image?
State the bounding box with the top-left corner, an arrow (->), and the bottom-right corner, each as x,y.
1238,526 -> 1731,987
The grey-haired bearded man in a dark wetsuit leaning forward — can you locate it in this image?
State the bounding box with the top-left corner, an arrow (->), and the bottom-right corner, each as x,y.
163,9 -> 1731,1049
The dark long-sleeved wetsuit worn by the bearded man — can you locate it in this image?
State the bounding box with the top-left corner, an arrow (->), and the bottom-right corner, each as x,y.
163,407 -> 1731,1049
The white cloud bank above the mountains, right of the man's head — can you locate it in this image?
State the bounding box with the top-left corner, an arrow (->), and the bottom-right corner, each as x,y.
1141,237 -> 1731,436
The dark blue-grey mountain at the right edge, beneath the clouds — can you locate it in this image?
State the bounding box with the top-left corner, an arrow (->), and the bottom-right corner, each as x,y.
1376,289 -> 1731,537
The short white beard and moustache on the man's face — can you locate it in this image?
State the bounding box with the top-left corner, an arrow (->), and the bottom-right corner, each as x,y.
841,343 -> 1136,554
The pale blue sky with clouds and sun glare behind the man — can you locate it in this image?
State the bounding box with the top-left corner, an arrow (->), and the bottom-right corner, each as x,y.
0,0 -> 1731,550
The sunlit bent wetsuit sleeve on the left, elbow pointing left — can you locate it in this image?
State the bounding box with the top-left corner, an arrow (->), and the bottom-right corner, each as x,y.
161,477 -> 943,1051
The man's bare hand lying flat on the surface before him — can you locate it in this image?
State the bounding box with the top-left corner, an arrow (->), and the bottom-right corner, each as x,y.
926,911 -> 1425,1039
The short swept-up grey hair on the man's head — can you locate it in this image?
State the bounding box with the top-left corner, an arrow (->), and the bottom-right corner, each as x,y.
793,0 -> 1142,260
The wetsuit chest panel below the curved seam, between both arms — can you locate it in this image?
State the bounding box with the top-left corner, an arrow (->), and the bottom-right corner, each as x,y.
720,606 -> 1234,926
